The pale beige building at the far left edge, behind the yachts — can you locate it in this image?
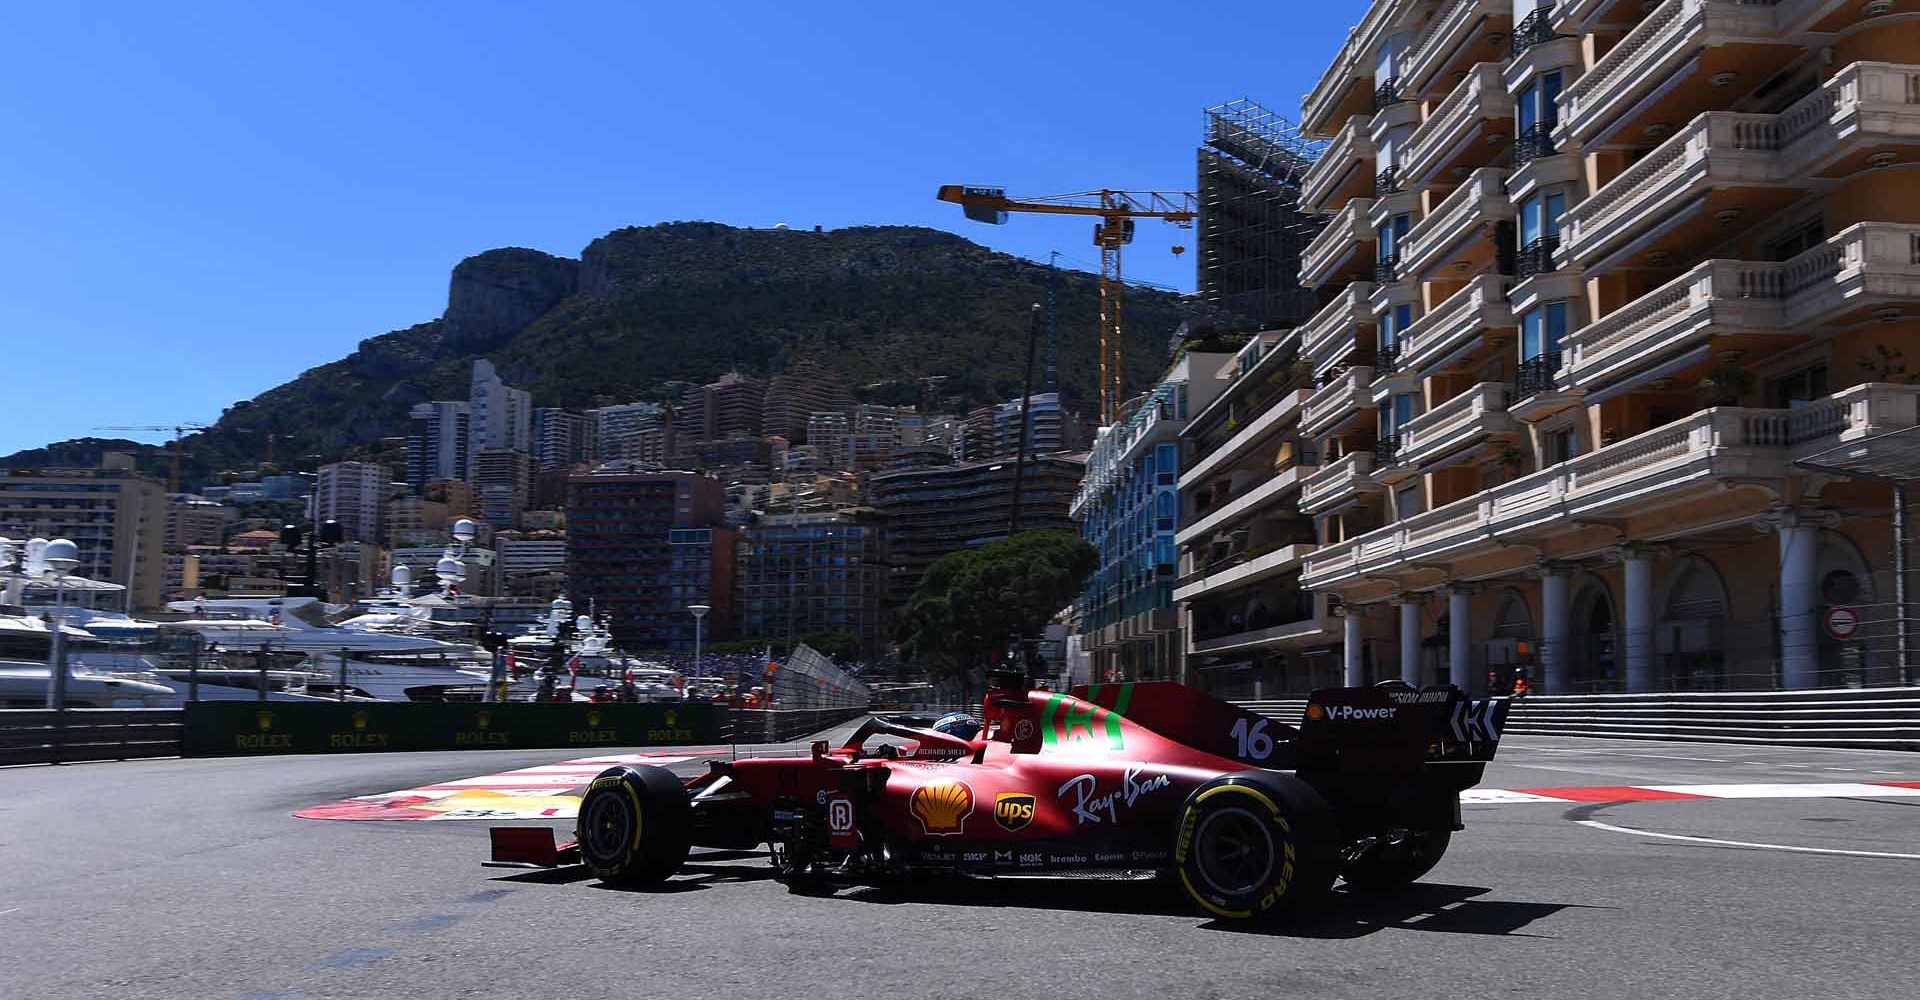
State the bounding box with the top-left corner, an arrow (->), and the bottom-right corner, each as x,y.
0,453 -> 167,608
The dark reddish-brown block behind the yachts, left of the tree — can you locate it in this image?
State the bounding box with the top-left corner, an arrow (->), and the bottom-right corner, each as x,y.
566,466 -> 737,651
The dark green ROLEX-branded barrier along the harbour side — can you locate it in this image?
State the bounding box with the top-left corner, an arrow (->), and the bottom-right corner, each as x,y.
182,701 -> 732,756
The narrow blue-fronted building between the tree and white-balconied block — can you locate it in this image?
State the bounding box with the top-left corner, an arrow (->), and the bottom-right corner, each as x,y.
1071,351 -> 1235,681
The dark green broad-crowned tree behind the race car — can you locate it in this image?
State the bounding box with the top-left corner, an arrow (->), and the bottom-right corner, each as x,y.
900,528 -> 1100,674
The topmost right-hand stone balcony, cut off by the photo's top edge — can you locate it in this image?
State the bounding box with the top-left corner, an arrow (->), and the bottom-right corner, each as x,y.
1555,0 -> 1782,144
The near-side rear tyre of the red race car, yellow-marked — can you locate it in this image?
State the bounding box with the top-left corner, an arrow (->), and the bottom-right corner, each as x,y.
1173,772 -> 1338,919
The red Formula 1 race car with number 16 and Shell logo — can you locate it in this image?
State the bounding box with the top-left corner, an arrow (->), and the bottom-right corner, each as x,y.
493,681 -> 1507,919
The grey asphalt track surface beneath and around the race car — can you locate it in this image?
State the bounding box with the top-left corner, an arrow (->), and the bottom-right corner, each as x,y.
0,725 -> 1920,1000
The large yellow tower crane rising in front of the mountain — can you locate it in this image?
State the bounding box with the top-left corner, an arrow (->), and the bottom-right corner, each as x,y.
937,184 -> 1200,424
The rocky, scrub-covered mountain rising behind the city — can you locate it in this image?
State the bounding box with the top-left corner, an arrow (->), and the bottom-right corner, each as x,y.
0,223 -> 1187,482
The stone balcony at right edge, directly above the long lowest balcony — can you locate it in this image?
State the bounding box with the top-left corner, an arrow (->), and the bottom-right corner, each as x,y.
1559,223 -> 1920,390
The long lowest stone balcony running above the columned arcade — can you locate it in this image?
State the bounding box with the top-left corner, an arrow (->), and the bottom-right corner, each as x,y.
1302,382 -> 1920,589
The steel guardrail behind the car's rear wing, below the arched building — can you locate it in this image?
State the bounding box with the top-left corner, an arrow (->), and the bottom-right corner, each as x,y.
1236,687 -> 1920,750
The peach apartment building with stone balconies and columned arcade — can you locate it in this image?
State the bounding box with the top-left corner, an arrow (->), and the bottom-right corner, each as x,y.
1300,0 -> 1920,693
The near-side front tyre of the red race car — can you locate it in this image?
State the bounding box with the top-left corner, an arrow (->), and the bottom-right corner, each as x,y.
574,766 -> 693,885
